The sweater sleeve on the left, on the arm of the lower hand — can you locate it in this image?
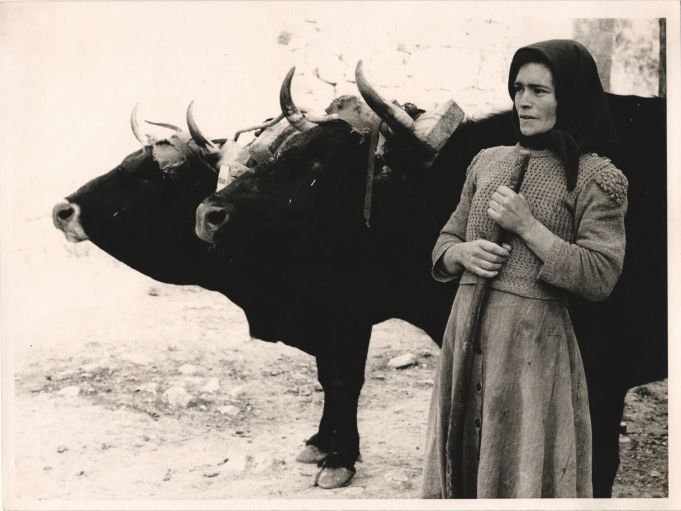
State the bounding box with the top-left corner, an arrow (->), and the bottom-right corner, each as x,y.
431,149 -> 485,282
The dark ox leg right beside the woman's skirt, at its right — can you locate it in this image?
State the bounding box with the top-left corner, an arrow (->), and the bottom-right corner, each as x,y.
589,386 -> 626,498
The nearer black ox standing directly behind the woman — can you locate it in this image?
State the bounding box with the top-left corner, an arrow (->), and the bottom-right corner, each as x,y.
196,67 -> 667,496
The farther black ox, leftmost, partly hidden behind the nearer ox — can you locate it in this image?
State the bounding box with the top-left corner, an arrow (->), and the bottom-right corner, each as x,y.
52,98 -> 376,488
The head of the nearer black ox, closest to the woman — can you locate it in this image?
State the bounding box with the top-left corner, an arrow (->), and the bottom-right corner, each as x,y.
196,69 -> 380,261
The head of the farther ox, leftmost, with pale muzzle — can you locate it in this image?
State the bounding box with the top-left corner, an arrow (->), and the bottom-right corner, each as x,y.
53,105 -> 224,280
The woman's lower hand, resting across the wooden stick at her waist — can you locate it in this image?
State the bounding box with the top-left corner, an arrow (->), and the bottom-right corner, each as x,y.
442,240 -> 511,279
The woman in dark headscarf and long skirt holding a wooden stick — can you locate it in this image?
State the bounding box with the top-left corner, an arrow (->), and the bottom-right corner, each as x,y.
423,40 -> 627,498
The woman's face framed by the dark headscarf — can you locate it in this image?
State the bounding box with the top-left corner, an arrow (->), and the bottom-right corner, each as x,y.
513,62 -> 558,136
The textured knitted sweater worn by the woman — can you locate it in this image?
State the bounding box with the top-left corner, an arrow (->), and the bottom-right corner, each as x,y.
433,145 -> 627,301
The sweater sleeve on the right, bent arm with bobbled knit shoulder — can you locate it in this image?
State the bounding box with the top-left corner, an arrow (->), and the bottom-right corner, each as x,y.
537,165 -> 627,302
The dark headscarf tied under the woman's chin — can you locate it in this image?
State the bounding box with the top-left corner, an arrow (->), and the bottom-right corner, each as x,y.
508,39 -> 617,190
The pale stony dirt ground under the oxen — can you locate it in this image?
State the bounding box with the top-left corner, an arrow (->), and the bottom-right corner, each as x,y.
13,276 -> 668,503
